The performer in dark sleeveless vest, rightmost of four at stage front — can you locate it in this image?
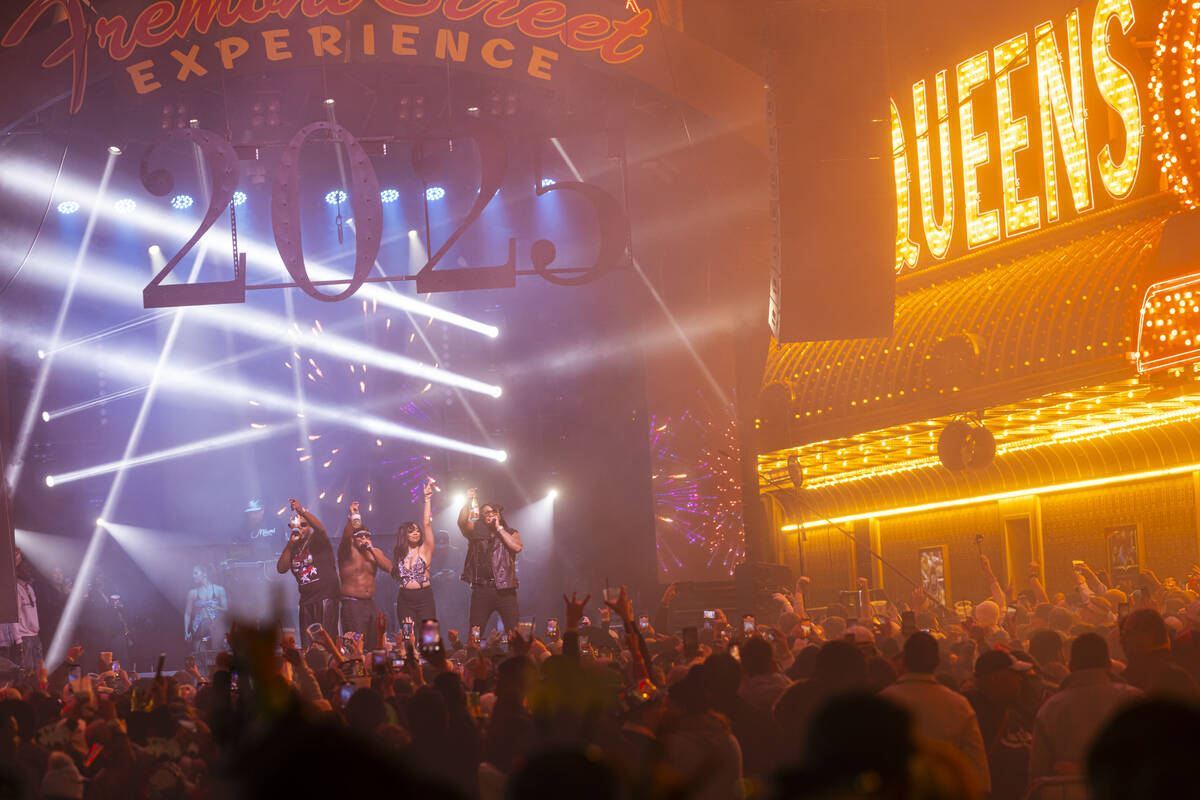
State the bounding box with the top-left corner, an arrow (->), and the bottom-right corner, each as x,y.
458,489 -> 523,631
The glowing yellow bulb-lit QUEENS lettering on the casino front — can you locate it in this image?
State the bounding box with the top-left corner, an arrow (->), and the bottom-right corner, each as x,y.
892,0 -> 1144,272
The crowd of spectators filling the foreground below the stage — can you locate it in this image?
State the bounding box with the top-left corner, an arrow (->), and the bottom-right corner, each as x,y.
0,542 -> 1200,800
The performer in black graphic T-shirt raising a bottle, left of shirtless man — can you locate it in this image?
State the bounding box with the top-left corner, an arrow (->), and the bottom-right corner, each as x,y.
275,498 -> 341,648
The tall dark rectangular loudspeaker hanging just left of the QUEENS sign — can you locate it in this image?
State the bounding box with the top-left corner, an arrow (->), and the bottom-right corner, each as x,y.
767,0 -> 896,342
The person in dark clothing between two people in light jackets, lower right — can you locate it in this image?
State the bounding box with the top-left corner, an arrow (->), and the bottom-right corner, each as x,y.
966,650 -> 1033,800
